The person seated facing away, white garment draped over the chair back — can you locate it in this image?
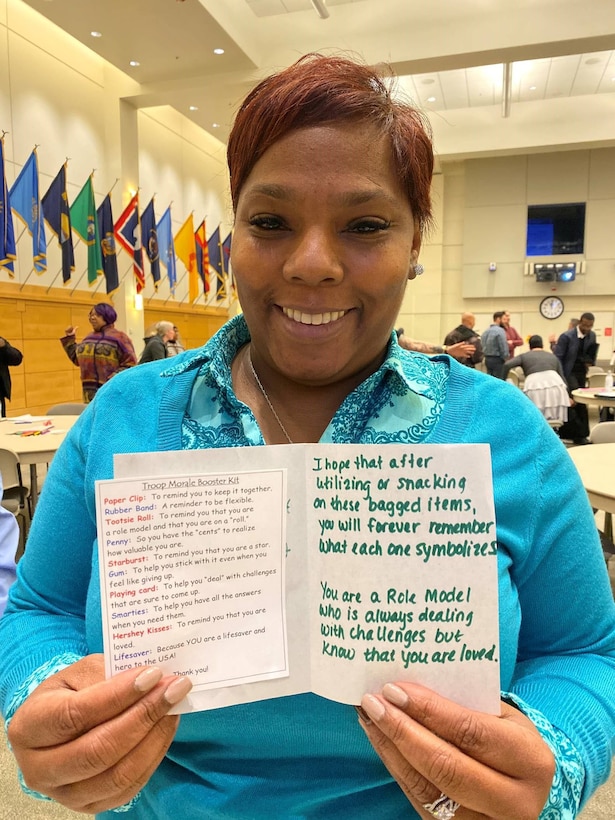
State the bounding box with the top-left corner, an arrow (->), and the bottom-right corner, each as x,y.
504,335 -> 570,423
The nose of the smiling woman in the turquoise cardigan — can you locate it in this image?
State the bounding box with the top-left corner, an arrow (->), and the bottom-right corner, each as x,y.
283,228 -> 344,285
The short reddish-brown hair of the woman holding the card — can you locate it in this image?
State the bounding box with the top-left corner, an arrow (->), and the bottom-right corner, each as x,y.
227,54 -> 434,233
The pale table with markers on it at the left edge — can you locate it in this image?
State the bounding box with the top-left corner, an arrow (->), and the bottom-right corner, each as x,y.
0,416 -> 79,509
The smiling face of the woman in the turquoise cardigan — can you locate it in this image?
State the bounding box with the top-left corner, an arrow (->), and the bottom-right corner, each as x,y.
232,125 -> 420,385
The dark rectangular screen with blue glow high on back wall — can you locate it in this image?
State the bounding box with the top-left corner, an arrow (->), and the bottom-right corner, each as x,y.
526,202 -> 585,256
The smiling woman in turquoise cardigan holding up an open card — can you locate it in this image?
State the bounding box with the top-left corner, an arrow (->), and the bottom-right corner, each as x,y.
0,55 -> 615,820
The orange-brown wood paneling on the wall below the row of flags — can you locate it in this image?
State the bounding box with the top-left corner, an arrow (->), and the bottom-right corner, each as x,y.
0,282 -> 228,416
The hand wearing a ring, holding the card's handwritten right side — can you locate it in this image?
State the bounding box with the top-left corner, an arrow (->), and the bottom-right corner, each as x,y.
360,683 -> 555,820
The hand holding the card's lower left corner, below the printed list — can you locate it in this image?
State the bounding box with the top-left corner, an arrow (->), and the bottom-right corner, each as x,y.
8,655 -> 192,814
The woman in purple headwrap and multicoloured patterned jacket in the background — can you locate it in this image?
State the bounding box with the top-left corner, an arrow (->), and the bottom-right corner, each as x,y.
60,302 -> 137,404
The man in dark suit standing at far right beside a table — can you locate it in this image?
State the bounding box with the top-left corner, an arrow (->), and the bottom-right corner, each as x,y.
555,313 -> 598,444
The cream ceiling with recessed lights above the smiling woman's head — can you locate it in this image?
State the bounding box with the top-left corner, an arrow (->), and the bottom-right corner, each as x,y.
19,0 -> 615,157
